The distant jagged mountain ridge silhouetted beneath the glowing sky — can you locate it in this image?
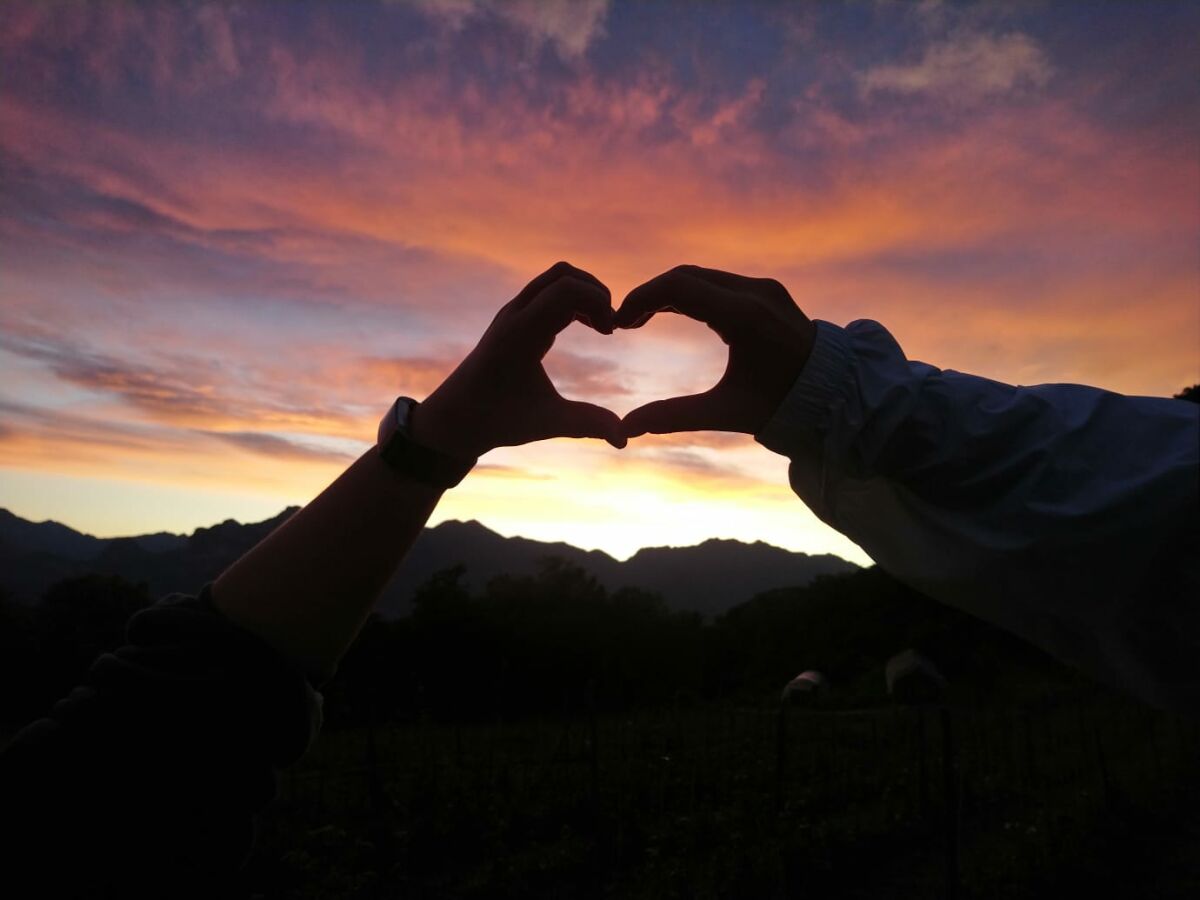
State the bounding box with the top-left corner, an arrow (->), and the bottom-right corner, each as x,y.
0,506 -> 858,617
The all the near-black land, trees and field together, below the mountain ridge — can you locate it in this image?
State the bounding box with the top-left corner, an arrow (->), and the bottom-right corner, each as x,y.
7,560 -> 1200,900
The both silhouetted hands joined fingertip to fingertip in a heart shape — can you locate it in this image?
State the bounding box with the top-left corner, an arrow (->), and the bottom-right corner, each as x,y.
412,263 -> 815,457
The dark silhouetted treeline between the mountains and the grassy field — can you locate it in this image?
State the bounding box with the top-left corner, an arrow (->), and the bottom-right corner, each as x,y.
0,559 -> 1078,727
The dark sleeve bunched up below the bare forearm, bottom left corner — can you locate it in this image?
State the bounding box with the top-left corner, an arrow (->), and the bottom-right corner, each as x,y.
0,588 -> 320,896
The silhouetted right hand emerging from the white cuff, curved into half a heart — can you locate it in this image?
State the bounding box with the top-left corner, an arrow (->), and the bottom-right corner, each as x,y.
613,265 -> 816,438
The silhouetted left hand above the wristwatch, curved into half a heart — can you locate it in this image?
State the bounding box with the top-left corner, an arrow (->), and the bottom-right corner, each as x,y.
412,263 -> 626,457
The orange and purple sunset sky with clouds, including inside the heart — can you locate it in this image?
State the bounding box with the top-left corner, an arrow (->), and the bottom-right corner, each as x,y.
0,0 -> 1200,562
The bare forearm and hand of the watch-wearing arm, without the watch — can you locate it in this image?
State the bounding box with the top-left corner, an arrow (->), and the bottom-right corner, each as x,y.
212,263 -> 625,680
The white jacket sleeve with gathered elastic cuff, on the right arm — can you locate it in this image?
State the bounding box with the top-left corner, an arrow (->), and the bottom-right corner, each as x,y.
756,320 -> 1200,712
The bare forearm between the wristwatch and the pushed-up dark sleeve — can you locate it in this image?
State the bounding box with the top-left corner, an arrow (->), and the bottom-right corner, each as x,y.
212,448 -> 442,677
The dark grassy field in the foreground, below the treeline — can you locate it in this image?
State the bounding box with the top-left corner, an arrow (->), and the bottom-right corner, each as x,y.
247,694 -> 1200,898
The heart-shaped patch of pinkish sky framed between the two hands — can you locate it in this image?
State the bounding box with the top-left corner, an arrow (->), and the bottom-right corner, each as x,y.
542,313 -> 728,416
